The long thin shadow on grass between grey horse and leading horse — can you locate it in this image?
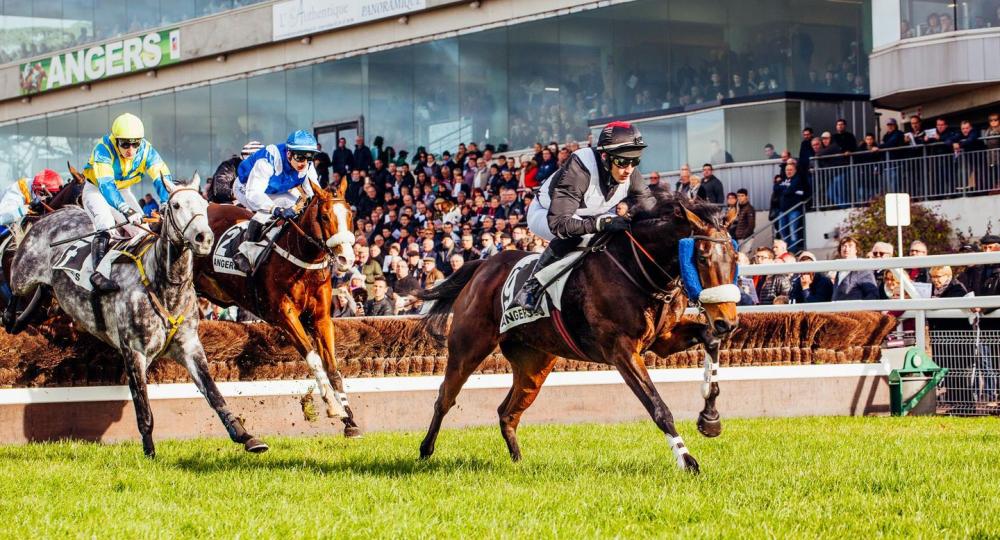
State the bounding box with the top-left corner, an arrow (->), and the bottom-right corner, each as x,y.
169,454 -> 502,478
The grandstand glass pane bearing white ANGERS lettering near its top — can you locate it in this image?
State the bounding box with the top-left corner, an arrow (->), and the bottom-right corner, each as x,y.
507,19 -> 569,148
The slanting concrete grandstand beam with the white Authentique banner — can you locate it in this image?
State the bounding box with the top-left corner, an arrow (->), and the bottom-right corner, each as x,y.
0,0 -> 600,122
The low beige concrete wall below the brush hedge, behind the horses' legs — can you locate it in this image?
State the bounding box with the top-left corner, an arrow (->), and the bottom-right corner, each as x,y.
0,374 -> 889,446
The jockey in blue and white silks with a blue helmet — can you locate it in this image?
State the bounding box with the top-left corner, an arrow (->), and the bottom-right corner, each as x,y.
232,129 -> 319,274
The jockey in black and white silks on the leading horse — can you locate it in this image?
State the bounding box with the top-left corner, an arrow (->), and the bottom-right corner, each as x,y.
514,122 -> 653,311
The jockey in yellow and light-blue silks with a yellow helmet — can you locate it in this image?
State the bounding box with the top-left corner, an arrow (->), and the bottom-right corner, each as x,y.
83,113 -> 170,293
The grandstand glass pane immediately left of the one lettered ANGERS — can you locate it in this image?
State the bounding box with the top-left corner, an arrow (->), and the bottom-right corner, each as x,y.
458,29 -> 507,152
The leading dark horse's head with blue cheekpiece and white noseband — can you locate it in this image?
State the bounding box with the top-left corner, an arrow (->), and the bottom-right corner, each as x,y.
632,192 -> 740,336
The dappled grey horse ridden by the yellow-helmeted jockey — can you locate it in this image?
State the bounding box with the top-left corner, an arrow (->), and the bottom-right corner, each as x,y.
11,175 -> 267,457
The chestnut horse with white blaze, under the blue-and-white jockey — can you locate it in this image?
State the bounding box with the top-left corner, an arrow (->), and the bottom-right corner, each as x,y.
195,179 -> 361,437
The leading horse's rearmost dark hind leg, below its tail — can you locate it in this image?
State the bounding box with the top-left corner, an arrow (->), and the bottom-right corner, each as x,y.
420,330 -> 497,459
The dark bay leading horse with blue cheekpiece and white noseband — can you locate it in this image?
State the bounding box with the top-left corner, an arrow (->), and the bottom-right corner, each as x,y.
420,192 -> 738,472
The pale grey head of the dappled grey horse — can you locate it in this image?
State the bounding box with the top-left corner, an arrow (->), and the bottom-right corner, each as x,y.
160,173 -> 215,257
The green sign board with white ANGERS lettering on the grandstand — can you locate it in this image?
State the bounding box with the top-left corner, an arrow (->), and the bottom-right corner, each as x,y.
21,28 -> 181,95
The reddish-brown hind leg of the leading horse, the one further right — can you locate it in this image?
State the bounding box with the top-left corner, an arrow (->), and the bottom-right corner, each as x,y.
497,345 -> 556,461
